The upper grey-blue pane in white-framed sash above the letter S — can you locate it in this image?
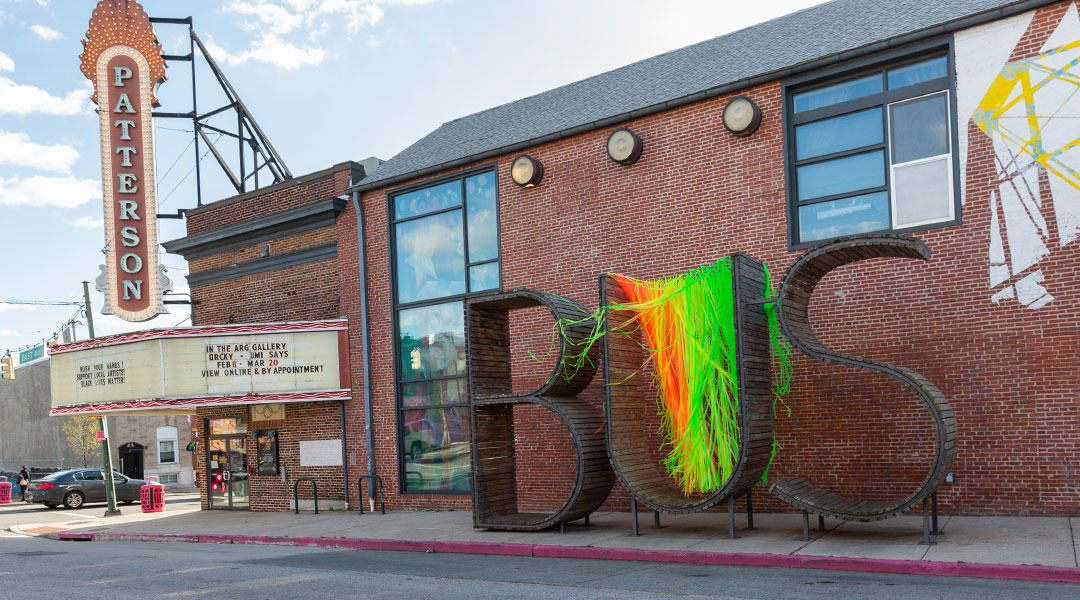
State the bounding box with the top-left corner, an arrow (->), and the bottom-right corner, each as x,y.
889,94 -> 948,164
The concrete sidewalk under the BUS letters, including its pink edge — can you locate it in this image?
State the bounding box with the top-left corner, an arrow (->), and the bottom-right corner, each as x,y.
11,509 -> 1080,583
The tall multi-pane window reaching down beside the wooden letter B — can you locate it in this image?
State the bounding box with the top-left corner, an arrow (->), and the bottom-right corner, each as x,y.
390,167 -> 501,493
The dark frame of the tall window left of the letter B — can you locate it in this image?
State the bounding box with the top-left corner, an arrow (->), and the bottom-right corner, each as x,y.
386,162 -> 502,496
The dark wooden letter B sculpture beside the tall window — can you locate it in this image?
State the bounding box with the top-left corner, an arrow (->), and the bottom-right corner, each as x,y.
465,289 -> 615,531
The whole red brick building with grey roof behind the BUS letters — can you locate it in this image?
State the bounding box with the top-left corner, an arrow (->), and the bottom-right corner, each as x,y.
111,0 -> 1080,515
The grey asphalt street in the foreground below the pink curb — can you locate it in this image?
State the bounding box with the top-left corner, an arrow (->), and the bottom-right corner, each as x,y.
0,532 -> 1080,600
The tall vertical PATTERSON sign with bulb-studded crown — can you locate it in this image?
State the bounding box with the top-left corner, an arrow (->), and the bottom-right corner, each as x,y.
79,0 -> 171,322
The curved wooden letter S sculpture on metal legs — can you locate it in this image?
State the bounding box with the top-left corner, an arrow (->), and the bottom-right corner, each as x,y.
770,235 -> 957,544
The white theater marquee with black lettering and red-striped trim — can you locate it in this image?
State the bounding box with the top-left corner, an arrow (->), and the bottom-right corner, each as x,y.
50,321 -> 350,414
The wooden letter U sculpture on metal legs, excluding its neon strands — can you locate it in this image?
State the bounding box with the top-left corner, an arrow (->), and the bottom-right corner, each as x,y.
599,253 -> 773,537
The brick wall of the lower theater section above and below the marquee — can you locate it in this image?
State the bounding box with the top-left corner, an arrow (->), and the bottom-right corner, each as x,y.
188,165 -> 359,510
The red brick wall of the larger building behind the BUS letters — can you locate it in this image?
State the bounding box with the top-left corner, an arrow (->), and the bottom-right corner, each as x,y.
338,0 -> 1080,515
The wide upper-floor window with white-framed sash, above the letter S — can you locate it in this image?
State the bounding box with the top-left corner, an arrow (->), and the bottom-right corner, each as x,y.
785,54 -> 959,246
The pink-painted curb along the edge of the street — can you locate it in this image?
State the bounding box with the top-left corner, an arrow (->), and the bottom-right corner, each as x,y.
56,531 -> 1080,583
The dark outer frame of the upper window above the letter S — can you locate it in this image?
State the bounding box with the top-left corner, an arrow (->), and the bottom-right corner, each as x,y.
781,36 -> 963,250
